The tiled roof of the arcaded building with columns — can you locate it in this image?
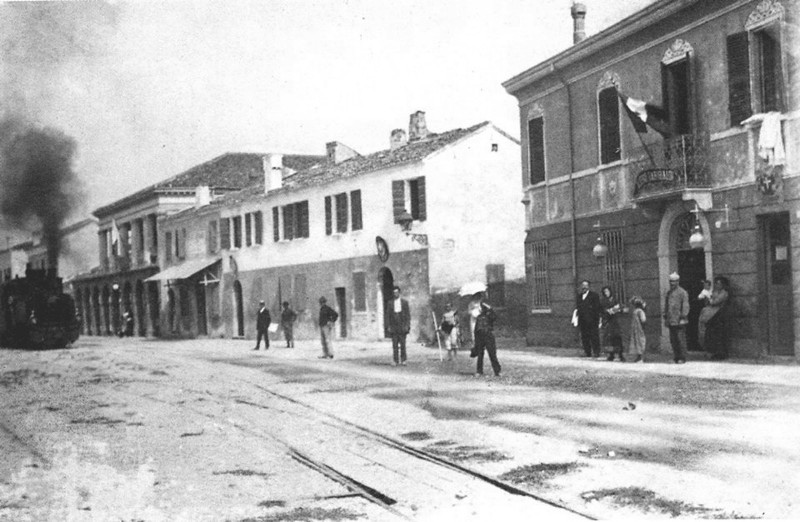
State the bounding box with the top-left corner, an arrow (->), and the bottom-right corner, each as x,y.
94,152 -> 326,217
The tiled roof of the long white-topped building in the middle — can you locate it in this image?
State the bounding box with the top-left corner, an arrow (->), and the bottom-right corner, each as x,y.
215,121 -> 490,205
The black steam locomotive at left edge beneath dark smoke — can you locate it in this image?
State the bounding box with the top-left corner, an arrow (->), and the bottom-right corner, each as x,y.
0,269 -> 80,349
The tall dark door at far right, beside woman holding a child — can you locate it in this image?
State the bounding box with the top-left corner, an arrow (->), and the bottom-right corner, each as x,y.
762,213 -> 794,355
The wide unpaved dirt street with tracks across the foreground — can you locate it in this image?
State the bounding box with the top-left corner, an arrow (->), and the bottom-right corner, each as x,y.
0,339 -> 800,521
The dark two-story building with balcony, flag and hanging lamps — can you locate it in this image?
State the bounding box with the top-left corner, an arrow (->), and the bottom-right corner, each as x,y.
503,0 -> 800,357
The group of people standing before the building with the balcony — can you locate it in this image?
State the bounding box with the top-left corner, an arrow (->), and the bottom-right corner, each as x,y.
573,272 -> 730,364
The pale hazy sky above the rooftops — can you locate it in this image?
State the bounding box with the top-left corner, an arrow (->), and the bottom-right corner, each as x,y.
0,0 -> 654,240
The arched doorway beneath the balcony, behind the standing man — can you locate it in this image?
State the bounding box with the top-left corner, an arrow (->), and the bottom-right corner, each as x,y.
658,201 -> 714,351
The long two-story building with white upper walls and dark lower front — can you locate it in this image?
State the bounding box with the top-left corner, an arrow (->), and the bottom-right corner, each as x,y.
151,111 -> 524,339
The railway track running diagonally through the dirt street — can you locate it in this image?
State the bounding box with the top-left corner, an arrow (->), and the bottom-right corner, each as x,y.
101,350 -> 592,520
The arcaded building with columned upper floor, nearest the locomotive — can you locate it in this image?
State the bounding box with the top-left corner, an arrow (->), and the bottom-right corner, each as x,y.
72,153 -> 321,335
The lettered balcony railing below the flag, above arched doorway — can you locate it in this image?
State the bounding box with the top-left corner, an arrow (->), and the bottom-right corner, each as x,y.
631,134 -> 710,200
